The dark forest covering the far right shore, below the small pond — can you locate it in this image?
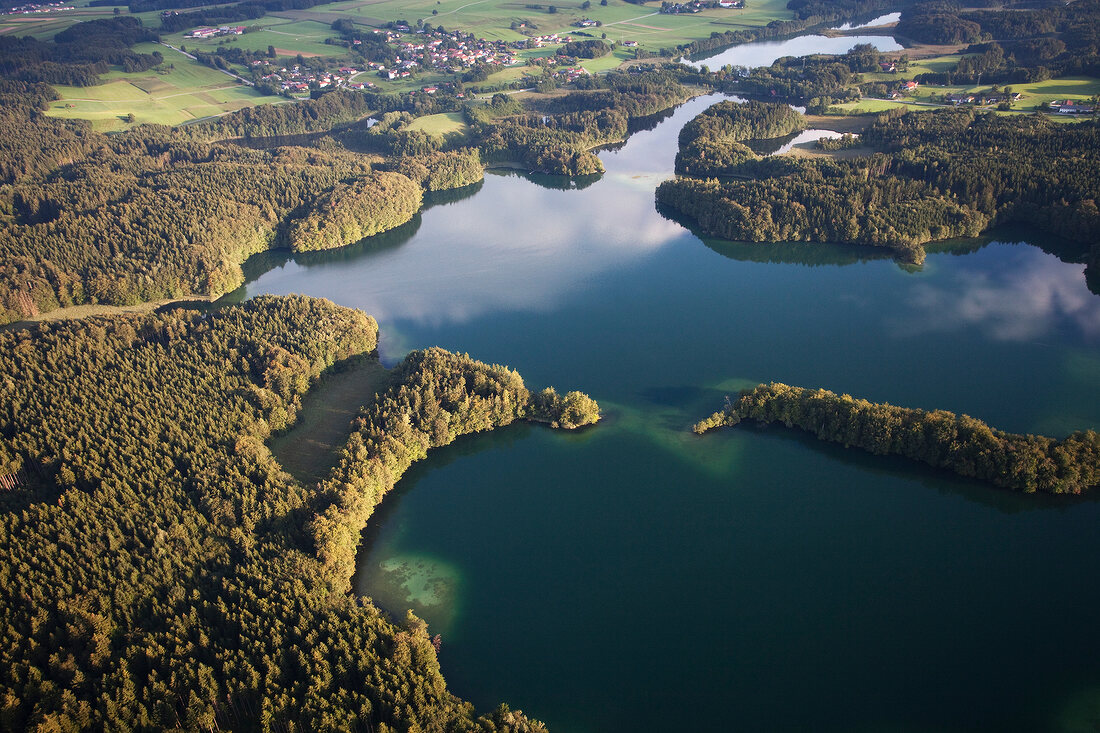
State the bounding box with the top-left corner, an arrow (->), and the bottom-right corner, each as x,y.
657,104 -> 1100,267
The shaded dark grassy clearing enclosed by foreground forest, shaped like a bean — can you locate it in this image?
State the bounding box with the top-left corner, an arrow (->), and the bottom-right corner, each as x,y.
270,358 -> 389,484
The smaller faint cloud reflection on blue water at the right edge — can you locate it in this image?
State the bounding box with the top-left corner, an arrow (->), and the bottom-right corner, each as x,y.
898,245 -> 1100,341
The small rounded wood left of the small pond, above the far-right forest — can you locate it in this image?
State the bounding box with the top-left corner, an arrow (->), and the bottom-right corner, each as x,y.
675,101 -> 806,177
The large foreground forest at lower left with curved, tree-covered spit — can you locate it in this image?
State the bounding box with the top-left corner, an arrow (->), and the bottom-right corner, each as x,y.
0,297 -> 598,733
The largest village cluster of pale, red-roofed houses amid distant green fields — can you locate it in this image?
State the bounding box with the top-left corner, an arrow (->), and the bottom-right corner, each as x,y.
369,31 -> 516,79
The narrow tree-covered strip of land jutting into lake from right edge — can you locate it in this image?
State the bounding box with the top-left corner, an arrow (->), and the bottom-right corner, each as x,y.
693,383 -> 1100,494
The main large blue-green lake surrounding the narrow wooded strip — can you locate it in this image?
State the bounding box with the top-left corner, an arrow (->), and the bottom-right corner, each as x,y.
242,97 -> 1100,733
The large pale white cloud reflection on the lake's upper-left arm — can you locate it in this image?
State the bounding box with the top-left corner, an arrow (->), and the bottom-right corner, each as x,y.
249,169 -> 685,327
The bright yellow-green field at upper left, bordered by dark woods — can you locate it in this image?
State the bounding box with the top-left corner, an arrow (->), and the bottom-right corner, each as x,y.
46,44 -> 285,132
